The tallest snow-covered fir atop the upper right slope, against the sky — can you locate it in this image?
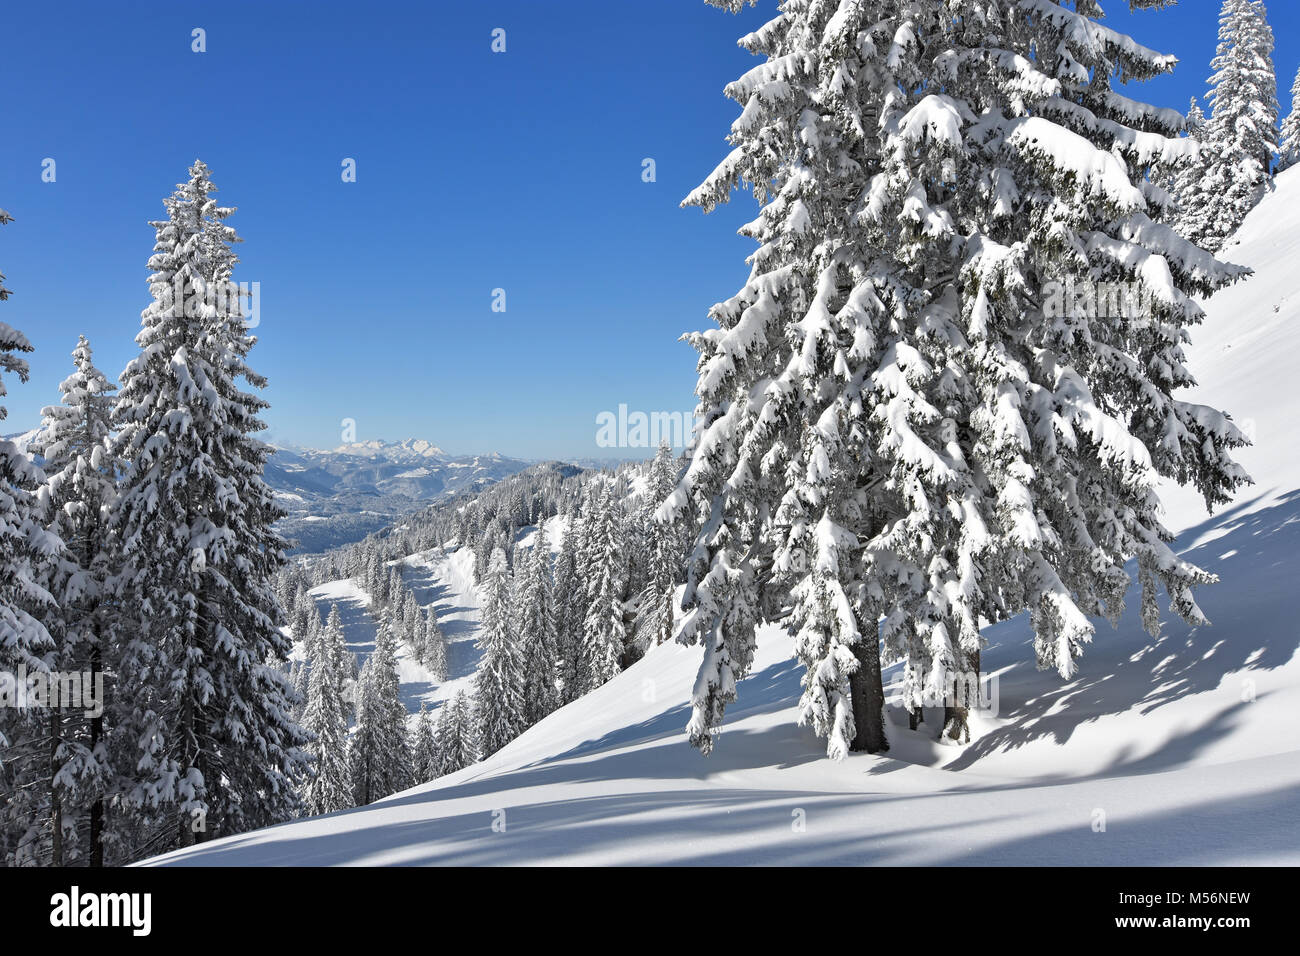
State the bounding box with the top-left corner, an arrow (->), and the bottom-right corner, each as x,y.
1178,0 -> 1278,251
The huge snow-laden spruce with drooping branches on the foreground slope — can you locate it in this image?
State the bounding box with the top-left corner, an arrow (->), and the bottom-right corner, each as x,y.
662,0 -> 1247,757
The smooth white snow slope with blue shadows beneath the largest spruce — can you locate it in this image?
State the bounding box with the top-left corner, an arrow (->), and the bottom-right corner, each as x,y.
152,169 -> 1300,865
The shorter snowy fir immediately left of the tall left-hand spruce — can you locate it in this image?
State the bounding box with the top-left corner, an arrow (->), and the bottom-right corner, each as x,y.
31,336 -> 120,866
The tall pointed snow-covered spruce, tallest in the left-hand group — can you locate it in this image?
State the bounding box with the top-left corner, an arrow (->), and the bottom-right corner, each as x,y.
114,161 -> 306,852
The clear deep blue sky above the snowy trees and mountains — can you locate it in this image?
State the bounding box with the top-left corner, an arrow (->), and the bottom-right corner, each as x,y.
0,0 -> 1300,458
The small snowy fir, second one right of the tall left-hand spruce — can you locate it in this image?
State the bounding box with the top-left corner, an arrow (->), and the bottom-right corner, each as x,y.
348,627 -> 411,806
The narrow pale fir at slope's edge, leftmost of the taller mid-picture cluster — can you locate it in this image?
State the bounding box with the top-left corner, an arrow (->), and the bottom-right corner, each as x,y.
475,548 -> 528,757
